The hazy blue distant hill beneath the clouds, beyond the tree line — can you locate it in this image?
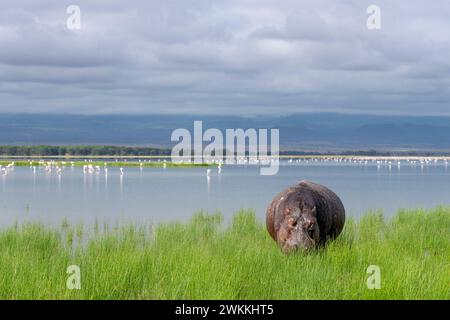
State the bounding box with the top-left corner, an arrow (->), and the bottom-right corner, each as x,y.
0,113 -> 450,151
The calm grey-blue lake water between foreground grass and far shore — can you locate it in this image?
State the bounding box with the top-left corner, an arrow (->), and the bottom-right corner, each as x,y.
0,161 -> 450,226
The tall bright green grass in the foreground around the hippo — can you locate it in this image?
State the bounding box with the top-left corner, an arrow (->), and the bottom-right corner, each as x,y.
0,208 -> 450,299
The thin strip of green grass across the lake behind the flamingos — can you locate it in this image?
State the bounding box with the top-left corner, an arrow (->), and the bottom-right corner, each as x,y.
0,160 -> 214,168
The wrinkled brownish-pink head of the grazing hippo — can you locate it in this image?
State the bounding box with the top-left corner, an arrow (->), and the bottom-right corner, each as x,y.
277,205 -> 319,253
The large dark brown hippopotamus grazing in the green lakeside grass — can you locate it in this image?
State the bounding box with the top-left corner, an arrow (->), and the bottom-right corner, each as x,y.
266,180 -> 345,253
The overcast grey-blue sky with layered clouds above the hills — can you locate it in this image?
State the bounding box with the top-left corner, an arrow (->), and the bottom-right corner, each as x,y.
0,0 -> 450,115
